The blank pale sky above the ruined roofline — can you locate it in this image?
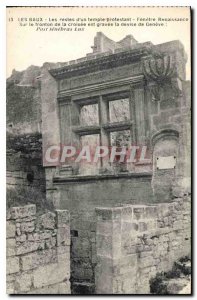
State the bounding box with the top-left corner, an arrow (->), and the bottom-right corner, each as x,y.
6,7 -> 191,79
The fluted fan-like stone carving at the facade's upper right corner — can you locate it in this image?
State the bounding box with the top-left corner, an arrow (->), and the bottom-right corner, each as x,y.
143,55 -> 182,101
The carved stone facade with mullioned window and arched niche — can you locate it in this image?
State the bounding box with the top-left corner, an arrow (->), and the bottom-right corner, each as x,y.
41,33 -> 191,293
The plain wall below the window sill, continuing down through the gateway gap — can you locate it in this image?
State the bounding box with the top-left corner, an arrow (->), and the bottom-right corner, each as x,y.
47,170 -> 153,293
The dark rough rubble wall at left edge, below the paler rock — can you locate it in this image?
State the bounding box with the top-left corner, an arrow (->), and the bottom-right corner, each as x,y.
6,133 -> 46,193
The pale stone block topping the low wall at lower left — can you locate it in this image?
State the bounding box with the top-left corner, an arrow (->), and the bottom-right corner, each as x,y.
10,204 -> 36,220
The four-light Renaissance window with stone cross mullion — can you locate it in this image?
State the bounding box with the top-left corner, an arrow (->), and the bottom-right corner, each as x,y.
69,91 -> 134,175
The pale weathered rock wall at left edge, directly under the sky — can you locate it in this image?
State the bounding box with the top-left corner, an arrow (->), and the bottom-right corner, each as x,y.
6,66 -> 41,134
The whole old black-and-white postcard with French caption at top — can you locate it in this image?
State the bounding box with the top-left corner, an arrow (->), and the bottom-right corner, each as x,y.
6,7 -> 191,295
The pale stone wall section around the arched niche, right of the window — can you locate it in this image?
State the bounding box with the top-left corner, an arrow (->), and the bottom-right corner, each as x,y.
149,81 -> 191,201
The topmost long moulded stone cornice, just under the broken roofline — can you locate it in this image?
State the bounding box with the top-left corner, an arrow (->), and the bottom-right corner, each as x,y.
49,45 -> 157,80
